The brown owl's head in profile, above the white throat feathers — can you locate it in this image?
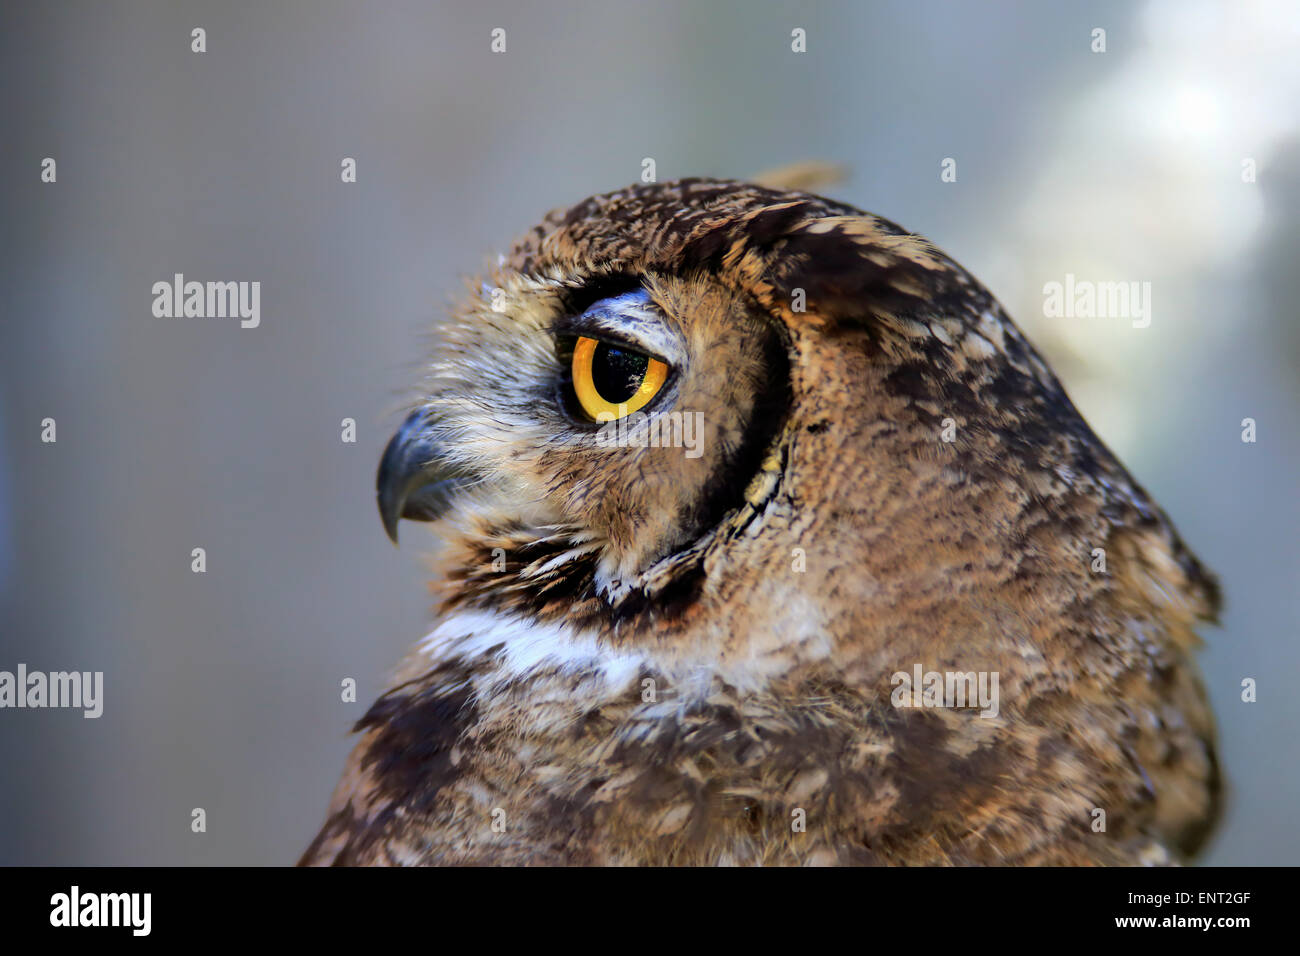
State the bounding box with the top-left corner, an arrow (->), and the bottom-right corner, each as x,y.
378,179 -> 1216,650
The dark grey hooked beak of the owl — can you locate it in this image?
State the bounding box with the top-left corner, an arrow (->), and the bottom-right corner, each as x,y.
374,410 -> 468,544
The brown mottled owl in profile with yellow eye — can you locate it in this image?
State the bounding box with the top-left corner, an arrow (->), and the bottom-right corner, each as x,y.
302,179 -> 1219,865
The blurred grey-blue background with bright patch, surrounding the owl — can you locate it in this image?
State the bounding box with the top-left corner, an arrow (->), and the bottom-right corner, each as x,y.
0,0 -> 1300,865
